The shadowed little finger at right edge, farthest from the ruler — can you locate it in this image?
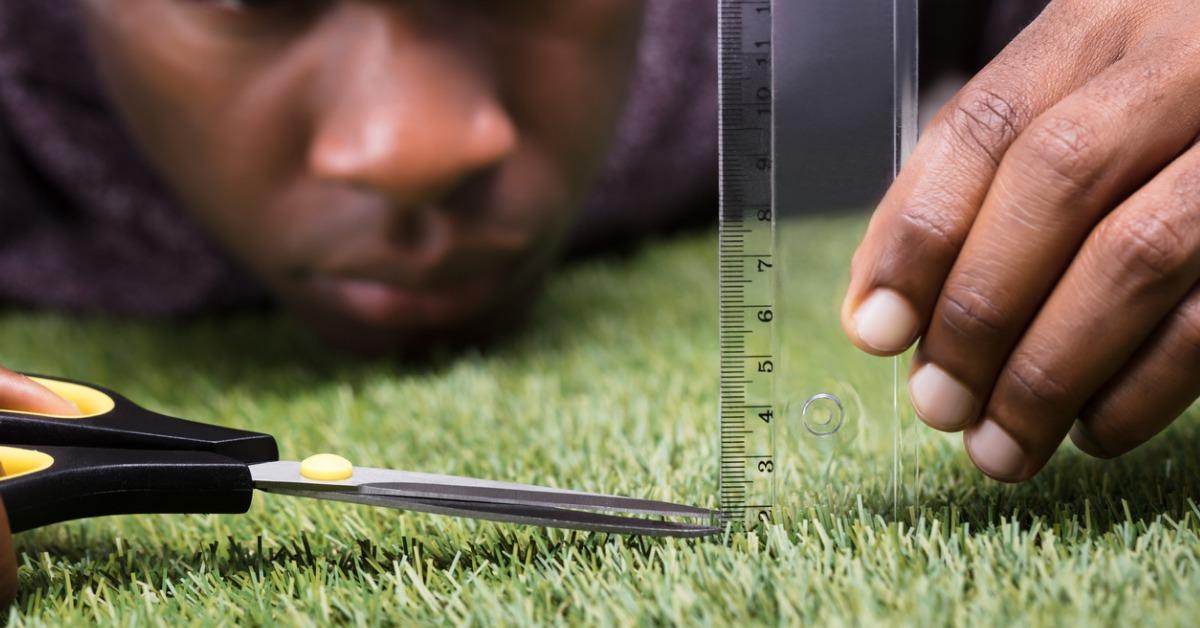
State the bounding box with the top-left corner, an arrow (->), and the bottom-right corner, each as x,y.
1070,287 -> 1200,457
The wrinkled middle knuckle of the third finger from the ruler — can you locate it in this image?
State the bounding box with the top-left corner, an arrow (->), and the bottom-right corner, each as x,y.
1097,211 -> 1192,285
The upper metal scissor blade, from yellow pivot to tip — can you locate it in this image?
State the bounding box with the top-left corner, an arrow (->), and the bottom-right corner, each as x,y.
359,482 -> 718,519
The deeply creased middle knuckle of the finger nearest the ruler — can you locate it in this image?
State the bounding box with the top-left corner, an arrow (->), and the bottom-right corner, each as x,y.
943,86 -> 1028,166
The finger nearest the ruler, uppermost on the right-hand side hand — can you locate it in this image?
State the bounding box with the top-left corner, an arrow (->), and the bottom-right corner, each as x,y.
841,2 -> 1134,355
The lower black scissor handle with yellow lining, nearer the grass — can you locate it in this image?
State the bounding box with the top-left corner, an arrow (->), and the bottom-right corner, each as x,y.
0,444 -> 254,532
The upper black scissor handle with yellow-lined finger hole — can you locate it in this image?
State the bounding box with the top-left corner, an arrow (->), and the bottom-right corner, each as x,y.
0,376 -> 280,463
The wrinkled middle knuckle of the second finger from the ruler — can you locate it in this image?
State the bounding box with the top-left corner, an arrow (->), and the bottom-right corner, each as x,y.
1021,116 -> 1106,190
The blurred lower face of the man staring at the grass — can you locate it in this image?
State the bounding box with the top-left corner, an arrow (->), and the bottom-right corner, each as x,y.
84,0 -> 642,351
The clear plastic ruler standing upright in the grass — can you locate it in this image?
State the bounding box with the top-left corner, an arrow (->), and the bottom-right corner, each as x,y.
719,0 -> 919,531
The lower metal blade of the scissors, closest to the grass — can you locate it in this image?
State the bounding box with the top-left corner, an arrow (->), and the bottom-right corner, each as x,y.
265,489 -> 721,538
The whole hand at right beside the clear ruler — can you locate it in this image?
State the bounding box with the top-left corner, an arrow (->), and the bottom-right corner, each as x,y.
842,0 -> 1200,482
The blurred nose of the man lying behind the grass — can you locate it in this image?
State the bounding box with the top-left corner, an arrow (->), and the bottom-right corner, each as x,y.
308,8 -> 517,208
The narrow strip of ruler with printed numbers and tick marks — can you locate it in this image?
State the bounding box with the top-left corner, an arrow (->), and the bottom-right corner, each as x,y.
719,0 -> 779,531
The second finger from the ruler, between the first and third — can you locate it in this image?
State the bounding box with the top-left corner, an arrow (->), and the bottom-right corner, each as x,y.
910,36 -> 1200,431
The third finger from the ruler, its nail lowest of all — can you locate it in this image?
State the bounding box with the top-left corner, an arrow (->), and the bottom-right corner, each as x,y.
965,146 -> 1200,482
